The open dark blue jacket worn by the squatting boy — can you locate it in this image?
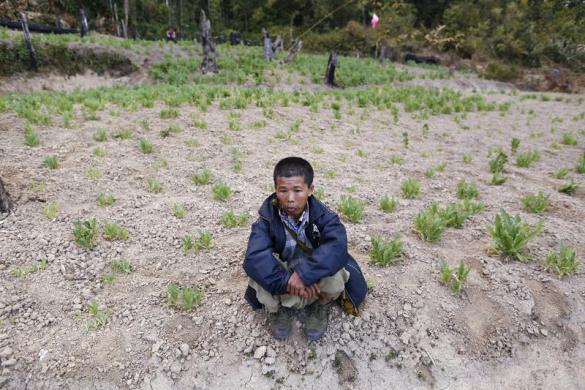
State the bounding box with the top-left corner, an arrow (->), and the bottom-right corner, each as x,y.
244,194 -> 367,314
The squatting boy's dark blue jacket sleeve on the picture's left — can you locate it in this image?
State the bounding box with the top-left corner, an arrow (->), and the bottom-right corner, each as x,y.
244,218 -> 290,295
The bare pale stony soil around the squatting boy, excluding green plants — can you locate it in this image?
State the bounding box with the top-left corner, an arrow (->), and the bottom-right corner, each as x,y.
0,67 -> 585,389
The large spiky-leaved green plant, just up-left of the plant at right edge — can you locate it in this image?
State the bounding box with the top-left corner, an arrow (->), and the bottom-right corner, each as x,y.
489,209 -> 542,261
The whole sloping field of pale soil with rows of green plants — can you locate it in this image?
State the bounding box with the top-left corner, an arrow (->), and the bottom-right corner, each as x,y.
0,32 -> 585,389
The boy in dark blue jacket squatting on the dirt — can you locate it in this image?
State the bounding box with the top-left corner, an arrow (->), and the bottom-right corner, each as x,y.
244,157 -> 367,341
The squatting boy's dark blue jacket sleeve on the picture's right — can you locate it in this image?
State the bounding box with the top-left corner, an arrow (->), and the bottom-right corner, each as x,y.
295,212 -> 349,286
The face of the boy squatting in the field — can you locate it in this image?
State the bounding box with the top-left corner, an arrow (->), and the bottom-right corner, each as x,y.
275,176 -> 313,220
